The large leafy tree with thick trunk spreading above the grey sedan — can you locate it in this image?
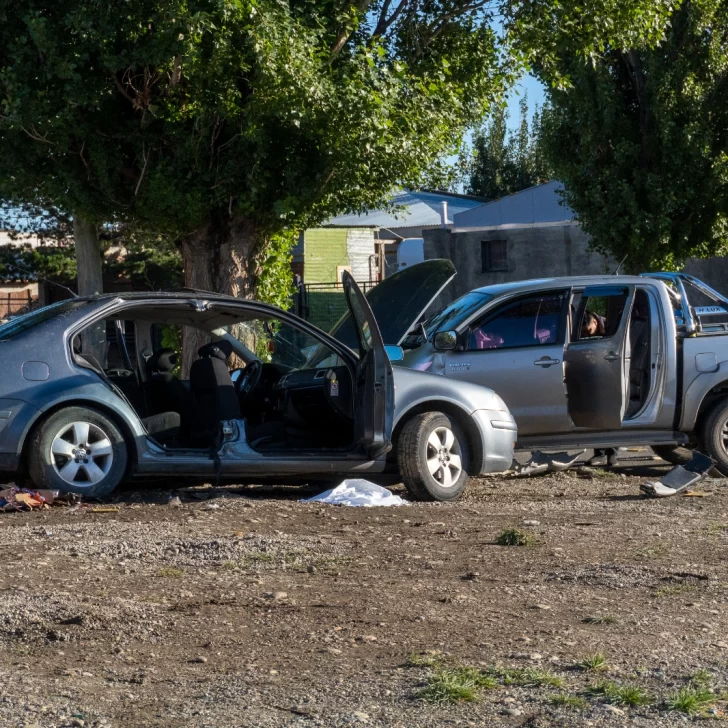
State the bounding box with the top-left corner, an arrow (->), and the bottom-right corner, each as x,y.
0,0 -> 684,296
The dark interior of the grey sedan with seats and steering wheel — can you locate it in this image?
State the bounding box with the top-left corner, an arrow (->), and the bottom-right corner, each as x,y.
72,306 -> 354,452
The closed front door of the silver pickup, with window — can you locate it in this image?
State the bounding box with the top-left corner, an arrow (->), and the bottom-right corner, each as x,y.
445,291 -> 573,435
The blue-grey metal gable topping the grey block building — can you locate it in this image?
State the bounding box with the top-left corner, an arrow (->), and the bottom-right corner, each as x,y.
452,180 -> 574,229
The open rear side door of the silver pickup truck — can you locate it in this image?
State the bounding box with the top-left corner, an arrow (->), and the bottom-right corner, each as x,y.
564,285 -> 634,430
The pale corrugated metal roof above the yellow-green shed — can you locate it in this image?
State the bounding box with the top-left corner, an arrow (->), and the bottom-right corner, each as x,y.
323,191 -> 483,229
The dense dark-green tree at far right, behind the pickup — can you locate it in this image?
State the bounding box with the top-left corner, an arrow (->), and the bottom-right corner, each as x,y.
542,0 -> 728,272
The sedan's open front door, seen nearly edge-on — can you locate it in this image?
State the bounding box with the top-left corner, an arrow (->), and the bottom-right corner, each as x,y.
342,271 -> 394,458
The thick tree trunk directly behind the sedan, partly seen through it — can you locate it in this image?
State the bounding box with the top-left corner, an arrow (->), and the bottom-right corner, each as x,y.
182,218 -> 263,378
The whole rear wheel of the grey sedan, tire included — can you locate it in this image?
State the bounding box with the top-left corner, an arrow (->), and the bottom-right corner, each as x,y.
27,407 -> 129,498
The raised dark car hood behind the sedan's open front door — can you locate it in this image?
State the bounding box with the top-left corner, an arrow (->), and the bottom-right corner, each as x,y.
329,259 -> 457,349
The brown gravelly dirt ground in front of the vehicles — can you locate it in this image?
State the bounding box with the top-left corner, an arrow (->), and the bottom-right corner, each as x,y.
0,453 -> 728,728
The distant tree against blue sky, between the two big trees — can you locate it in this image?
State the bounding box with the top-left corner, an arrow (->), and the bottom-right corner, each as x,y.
468,97 -> 551,200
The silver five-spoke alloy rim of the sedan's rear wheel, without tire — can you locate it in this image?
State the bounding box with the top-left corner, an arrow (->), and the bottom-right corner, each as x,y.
51,422 -> 114,487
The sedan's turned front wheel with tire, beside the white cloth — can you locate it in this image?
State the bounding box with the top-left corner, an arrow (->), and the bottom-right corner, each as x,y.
397,412 -> 470,501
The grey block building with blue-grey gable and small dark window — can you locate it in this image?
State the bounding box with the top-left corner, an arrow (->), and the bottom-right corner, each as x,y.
424,180 -> 728,305
